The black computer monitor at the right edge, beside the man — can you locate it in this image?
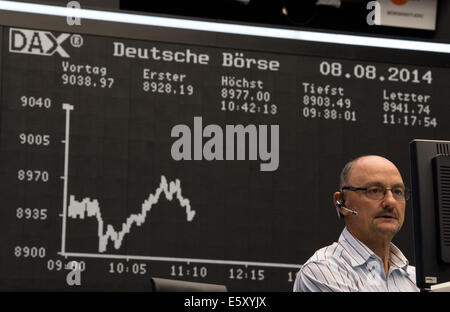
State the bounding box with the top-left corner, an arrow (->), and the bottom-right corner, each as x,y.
410,140 -> 450,289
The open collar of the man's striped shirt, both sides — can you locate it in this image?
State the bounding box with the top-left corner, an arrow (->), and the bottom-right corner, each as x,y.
339,227 -> 408,268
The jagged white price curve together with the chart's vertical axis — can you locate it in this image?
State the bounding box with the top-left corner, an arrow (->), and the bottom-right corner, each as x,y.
61,103 -> 195,254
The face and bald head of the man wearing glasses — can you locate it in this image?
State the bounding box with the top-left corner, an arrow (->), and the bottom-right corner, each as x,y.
344,156 -> 406,241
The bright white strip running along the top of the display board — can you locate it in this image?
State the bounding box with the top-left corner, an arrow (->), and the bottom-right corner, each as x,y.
0,0 -> 450,53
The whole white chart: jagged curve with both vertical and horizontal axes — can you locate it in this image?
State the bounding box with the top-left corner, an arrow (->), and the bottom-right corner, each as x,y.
58,104 -> 299,269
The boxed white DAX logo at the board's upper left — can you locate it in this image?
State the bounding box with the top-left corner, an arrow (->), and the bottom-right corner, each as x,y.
9,28 -> 70,57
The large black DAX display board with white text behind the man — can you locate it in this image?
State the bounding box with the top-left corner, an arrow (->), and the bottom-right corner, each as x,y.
0,7 -> 450,291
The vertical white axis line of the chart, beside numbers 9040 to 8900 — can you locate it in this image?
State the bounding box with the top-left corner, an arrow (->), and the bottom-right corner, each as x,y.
61,103 -> 73,253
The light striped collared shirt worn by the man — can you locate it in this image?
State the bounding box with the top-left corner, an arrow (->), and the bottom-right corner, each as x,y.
294,228 -> 419,292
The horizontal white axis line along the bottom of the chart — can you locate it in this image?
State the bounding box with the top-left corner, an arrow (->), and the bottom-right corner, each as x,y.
58,252 -> 301,269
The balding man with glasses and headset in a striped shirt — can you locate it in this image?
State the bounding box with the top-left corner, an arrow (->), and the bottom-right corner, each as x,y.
294,156 -> 419,292
